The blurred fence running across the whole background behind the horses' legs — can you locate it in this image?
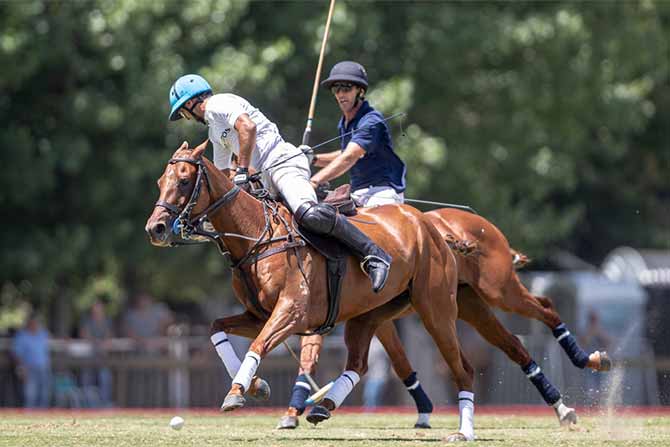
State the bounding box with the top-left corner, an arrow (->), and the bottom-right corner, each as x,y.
0,325 -> 670,408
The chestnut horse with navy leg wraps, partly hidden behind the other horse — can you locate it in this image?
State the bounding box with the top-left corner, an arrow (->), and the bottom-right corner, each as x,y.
277,208 -> 611,428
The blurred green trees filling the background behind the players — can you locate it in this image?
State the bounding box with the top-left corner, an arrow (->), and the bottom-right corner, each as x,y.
0,0 -> 670,332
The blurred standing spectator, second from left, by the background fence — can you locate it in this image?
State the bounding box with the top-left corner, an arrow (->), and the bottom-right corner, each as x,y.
79,300 -> 114,406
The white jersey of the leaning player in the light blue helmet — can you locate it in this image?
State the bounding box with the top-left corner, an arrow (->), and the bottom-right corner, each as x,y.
205,93 -> 284,170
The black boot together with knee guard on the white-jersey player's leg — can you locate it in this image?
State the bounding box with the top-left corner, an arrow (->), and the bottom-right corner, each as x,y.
295,202 -> 391,293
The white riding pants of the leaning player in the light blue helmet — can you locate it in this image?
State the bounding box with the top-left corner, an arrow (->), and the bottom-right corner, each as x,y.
263,142 -> 317,213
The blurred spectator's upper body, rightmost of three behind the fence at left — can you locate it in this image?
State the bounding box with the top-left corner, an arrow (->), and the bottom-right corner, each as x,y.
123,293 -> 174,351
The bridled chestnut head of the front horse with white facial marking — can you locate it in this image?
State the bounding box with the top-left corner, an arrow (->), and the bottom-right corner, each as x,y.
145,141 -> 212,247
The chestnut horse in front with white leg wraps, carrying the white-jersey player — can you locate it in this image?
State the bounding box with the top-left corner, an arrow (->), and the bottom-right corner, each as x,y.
146,143 -> 474,440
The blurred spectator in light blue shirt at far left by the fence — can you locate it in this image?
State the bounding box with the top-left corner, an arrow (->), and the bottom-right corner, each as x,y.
12,314 -> 51,408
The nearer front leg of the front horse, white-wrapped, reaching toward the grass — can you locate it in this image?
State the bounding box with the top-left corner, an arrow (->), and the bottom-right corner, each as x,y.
221,297 -> 307,411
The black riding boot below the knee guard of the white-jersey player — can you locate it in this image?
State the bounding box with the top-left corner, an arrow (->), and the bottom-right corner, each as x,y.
330,214 -> 391,293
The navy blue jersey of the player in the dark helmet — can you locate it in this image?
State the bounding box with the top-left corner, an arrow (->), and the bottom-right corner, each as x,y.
337,101 -> 407,193
